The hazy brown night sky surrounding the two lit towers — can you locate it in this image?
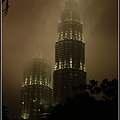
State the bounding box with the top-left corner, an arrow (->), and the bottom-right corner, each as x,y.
2,0 -> 118,116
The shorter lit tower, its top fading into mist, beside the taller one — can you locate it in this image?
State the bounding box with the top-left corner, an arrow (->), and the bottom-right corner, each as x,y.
21,58 -> 52,120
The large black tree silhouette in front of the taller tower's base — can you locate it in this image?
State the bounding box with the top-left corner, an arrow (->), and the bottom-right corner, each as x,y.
47,79 -> 118,120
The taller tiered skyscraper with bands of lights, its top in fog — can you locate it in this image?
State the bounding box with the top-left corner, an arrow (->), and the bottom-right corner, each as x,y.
53,0 -> 86,104
